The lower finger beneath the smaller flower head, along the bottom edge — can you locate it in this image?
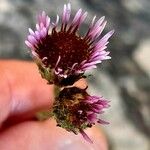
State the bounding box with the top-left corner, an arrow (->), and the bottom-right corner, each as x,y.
0,120 -> 107,150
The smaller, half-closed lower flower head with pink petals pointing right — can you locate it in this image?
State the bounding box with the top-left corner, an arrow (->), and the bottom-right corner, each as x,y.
53,87 -> 109,143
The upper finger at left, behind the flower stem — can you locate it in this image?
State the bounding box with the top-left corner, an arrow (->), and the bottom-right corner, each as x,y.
0,60 -> 54,122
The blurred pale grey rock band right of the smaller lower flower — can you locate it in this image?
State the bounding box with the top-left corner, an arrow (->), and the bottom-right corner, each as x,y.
89,70 -> 149,150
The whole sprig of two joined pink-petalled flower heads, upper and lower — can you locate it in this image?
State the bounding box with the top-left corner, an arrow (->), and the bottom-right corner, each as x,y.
25,3 -> 114,143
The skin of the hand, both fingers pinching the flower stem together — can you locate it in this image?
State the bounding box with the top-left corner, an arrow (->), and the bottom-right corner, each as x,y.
0,60 -> 108,150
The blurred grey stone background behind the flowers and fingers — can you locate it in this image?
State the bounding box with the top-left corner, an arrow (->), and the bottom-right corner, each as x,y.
0,0 -> 150,150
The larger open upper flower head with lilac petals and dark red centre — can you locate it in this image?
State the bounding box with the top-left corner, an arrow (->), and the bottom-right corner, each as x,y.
25,3 -> 114,83
